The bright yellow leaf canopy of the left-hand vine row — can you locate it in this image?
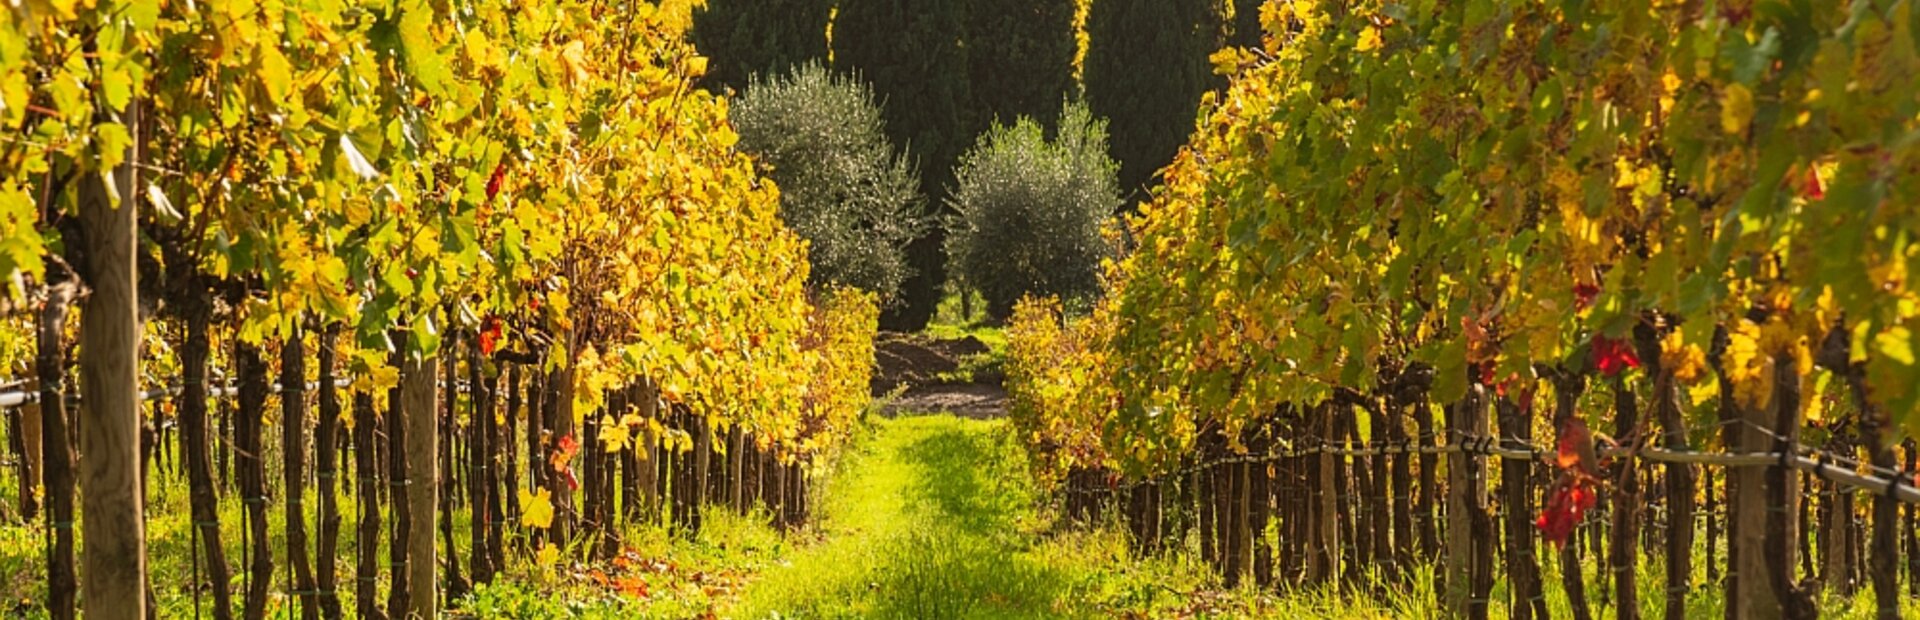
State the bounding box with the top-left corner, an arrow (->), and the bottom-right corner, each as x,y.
0,0 -> 872,456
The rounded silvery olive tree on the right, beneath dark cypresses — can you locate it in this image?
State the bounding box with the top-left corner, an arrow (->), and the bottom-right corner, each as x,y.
947,104 -> 1121,321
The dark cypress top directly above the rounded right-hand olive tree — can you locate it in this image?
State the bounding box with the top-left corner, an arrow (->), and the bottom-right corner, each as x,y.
966,0 -> 1073,129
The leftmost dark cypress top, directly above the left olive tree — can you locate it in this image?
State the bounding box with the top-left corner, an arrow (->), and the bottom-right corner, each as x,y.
691,0 -> 833,90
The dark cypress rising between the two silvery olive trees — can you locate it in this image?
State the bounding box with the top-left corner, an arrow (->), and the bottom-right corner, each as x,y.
833,0 -> 981,330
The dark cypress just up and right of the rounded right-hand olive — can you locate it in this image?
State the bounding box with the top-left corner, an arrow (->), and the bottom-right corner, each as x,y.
1083,0 -> 1225,200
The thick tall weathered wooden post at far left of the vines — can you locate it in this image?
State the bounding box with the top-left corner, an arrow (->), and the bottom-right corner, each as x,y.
77,102 -> 146,618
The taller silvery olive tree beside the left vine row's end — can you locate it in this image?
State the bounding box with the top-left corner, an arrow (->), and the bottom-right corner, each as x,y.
732,63 -> 931,301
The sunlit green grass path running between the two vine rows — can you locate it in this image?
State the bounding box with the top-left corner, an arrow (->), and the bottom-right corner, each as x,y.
732,415 -> 1213,618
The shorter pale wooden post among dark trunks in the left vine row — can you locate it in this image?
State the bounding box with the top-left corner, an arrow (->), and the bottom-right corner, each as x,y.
394,355 -> 440,620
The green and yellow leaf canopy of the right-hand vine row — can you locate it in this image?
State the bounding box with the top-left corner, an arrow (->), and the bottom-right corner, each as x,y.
1010,0 -> 1920,476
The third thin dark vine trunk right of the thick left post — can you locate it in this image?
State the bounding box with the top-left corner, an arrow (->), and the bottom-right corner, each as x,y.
280,328 -> 324,620
